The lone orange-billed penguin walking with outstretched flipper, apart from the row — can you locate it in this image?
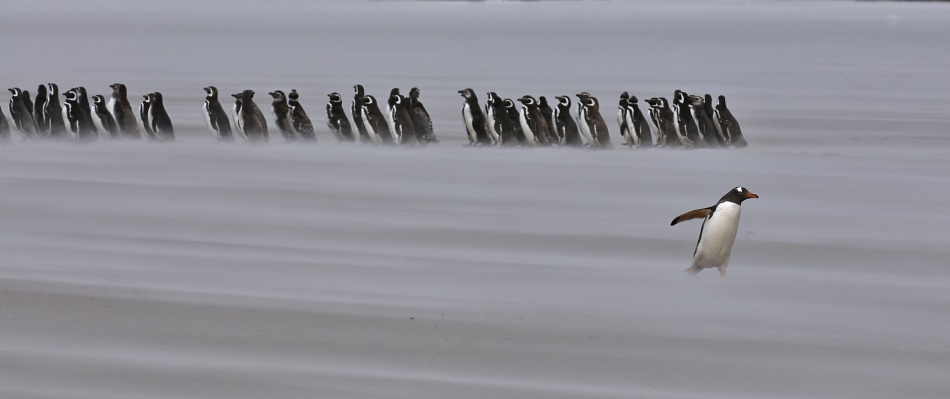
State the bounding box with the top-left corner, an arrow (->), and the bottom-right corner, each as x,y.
670,187 -> 759,276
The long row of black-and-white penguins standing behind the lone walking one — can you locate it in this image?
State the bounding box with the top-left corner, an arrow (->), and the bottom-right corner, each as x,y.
0,83 -> 747,149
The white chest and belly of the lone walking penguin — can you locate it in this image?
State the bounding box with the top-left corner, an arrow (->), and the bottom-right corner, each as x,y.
693,202 -> 741,268
